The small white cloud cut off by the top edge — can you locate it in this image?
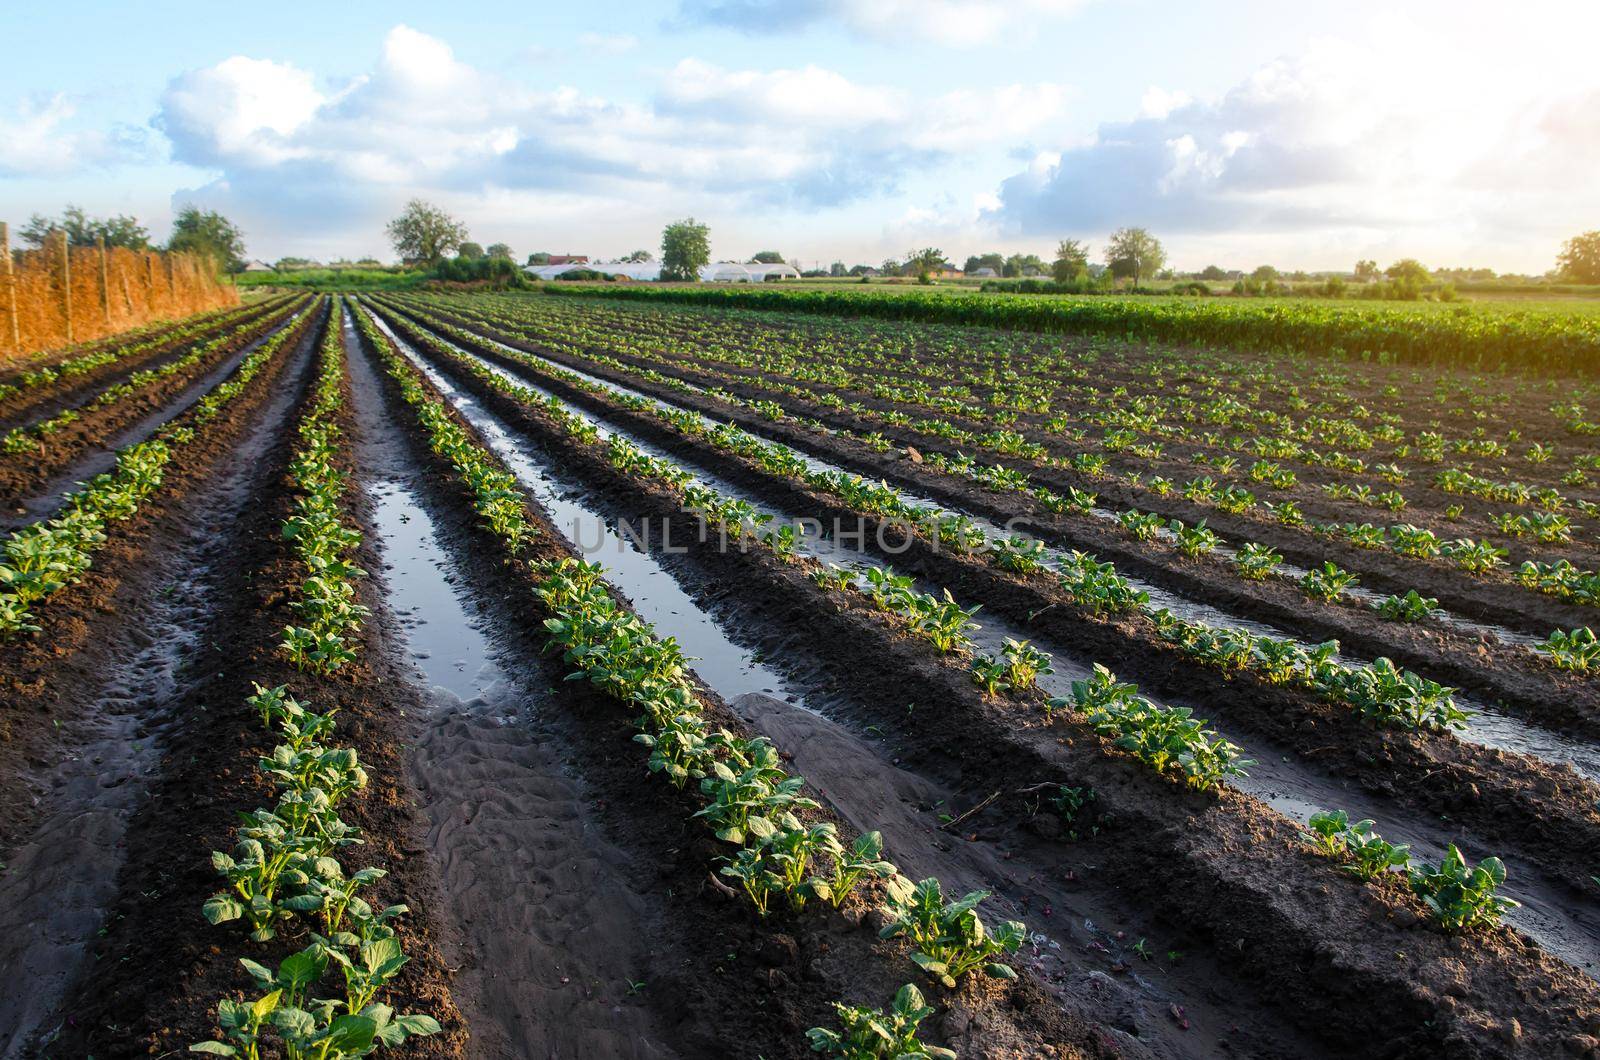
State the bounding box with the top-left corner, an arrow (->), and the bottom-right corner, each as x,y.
675,0 -> 1088,48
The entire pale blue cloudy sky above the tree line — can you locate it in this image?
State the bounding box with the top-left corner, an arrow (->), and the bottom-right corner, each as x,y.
0,0 -> 1600,274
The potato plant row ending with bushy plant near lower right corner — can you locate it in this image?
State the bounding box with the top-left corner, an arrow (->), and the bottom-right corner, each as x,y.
387,301 -> 1517,947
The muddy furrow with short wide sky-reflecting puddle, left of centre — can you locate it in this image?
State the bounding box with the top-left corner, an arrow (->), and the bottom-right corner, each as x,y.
346,320 -> 675,1060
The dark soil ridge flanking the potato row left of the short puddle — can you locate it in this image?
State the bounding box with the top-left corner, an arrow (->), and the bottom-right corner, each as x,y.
42,305 -> 467,1057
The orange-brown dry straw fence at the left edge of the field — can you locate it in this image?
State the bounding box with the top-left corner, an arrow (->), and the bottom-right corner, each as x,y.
0,221 -> 238,362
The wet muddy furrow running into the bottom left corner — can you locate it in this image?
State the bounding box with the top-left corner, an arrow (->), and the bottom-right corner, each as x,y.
0,337 -> 309,1057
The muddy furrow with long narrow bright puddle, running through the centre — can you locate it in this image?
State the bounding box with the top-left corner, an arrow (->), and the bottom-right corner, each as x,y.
363,307 -> 1337,1055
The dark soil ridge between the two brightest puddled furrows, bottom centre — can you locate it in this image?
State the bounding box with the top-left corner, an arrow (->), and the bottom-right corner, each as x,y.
355,301 -> 1120,1058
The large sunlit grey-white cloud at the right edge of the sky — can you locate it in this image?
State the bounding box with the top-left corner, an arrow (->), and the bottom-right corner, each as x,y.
987,34 -> 1600,252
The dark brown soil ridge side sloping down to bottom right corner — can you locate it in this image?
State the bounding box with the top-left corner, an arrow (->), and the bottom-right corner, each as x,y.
360,299 -> 1600,1055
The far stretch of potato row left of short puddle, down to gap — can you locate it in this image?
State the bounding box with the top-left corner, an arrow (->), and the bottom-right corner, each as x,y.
282,303 -> 366,674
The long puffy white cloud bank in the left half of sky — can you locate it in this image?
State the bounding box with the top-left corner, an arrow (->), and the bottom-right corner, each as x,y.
158,26 -> 1064,217
